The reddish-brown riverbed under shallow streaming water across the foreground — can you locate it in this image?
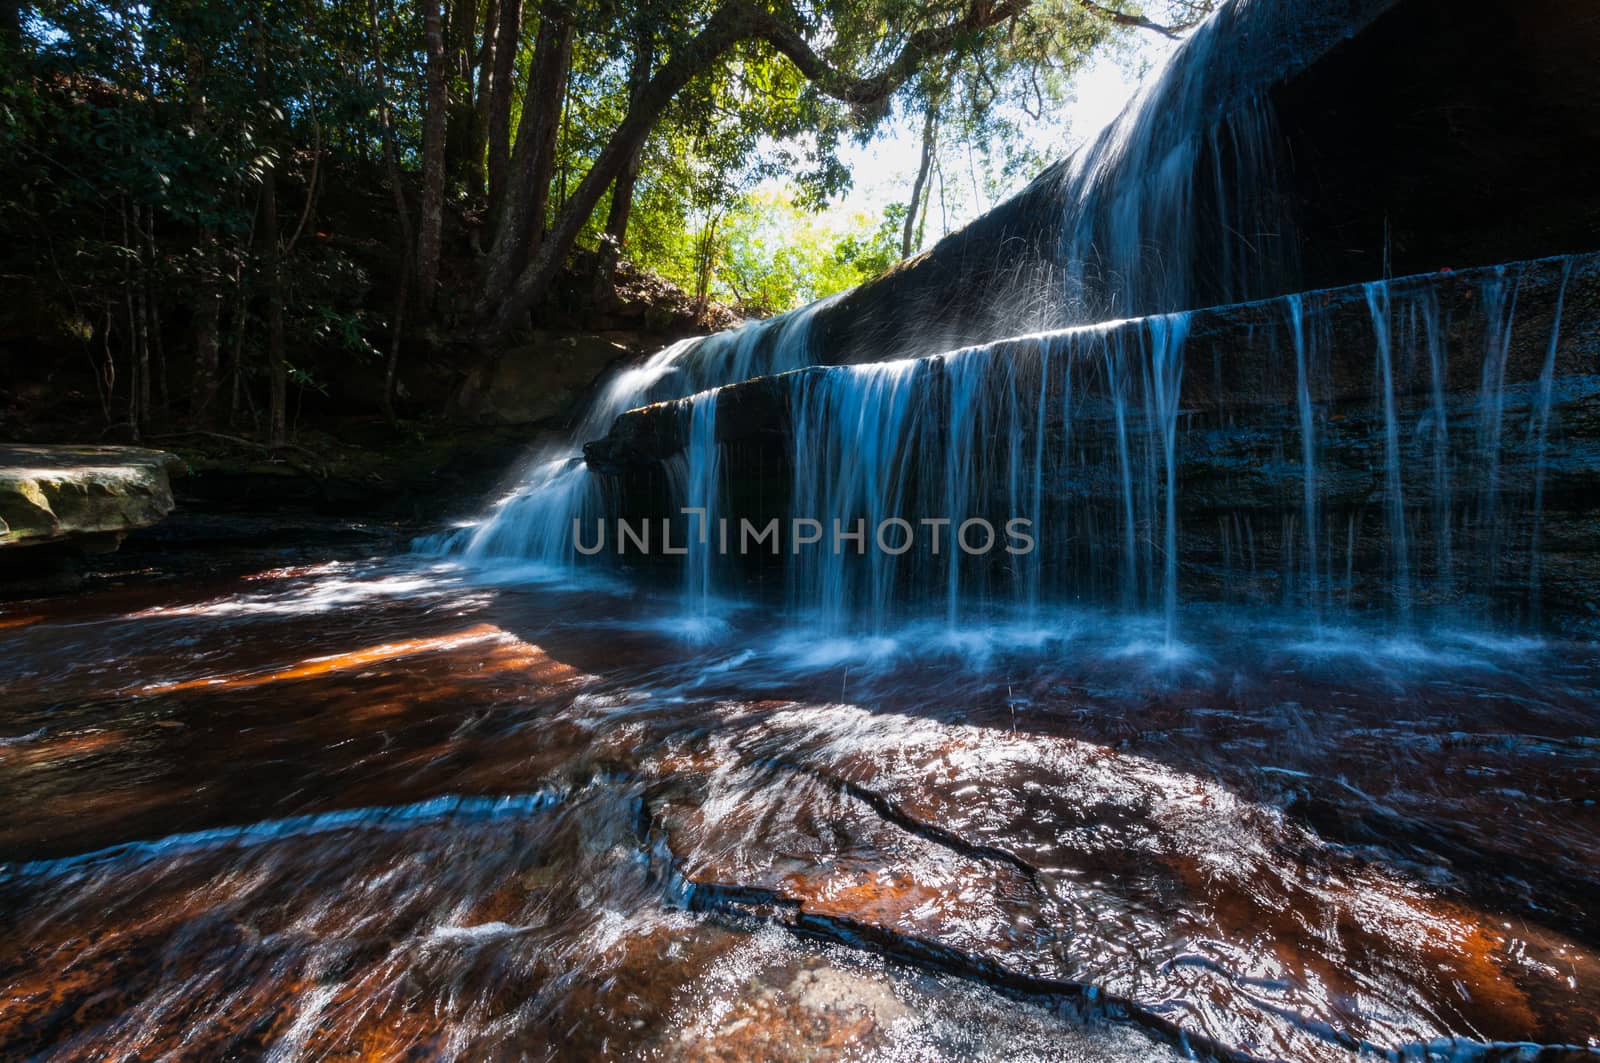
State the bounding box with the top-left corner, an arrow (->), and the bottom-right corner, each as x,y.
0,562 -> 1600,1060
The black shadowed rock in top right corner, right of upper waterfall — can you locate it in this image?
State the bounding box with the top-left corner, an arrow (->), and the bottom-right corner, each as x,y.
1275,0 -> 1600,287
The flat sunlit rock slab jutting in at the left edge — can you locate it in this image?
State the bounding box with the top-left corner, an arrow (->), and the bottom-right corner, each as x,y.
0,443 -> 184,549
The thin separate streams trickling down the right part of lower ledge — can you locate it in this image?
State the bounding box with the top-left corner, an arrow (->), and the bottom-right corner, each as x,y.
1241,259 -> 1571,624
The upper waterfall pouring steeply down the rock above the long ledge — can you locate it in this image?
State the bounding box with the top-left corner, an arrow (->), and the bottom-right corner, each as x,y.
1058,0 -> 1299,323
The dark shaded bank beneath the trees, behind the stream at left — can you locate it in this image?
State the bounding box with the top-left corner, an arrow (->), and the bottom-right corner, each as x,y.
0,150 -> 739,517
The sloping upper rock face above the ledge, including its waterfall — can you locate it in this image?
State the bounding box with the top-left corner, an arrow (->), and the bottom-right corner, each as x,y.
784,0 -> 1600,363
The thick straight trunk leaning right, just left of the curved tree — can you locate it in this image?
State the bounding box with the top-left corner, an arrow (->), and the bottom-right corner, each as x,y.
485,5 -> 576,312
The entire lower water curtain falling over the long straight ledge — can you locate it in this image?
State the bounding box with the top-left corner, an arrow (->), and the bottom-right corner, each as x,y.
461,259 -> 1597,644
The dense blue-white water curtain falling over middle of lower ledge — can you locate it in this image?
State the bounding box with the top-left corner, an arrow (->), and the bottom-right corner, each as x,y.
656,315 -> 1187,637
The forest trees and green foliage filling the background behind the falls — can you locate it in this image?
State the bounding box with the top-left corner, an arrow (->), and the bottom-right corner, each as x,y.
0,0 -> 1203,443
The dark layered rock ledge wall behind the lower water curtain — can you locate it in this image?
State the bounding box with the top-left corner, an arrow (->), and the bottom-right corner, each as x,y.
586,256 -> 1600,626
